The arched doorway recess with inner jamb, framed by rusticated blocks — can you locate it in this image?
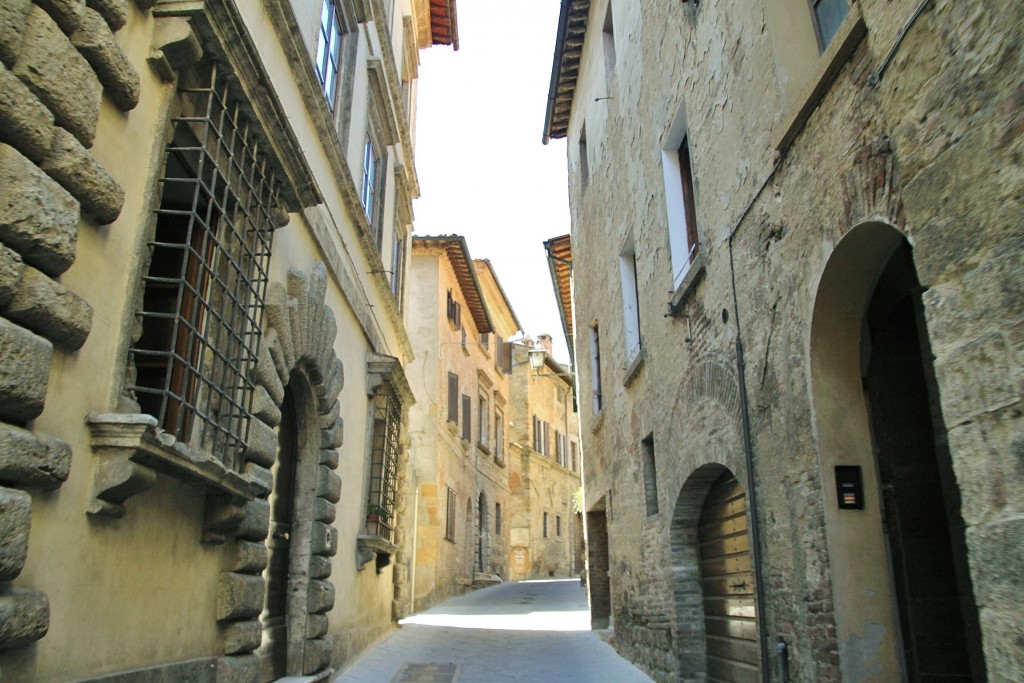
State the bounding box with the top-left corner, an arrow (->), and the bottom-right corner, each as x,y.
259,370 -> 319,683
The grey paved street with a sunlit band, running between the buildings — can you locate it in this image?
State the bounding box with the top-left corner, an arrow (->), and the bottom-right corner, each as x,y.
335,580 -> 650,683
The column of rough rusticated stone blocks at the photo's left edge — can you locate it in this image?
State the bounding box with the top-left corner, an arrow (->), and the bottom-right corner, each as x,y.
0,0 -> 139,650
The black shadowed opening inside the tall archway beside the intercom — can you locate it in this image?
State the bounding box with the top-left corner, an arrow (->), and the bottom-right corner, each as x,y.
861,241 -> 985,683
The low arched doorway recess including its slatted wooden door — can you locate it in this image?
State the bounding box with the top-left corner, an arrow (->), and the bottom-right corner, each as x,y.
671,464 -> 761,683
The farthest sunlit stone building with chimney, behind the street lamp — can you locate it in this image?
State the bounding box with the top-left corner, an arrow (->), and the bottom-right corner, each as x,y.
509,335 -> 583,581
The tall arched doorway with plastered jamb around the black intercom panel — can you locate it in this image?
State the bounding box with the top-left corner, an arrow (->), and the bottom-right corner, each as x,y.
810,222 -> 984,682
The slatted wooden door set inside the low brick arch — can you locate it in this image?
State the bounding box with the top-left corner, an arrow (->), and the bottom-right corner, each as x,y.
697,472 -> 759,683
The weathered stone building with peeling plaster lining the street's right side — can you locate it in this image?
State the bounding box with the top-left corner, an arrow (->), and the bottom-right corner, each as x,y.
544,0 -> 1024,683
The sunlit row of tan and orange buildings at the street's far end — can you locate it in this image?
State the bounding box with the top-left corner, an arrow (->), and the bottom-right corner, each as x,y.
408,240 -> 583,610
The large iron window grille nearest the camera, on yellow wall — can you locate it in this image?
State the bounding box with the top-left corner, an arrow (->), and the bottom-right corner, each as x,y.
128,63 -> 279,469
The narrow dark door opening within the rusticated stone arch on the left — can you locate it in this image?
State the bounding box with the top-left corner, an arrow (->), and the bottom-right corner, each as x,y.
260,391 -> 299,683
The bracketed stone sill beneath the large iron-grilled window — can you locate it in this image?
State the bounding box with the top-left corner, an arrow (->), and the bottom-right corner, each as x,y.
86,413 -> 271,517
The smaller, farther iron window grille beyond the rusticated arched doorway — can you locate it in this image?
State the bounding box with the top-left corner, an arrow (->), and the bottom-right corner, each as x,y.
367,382 -> 401,542
